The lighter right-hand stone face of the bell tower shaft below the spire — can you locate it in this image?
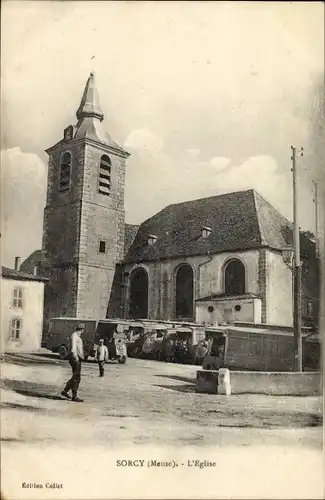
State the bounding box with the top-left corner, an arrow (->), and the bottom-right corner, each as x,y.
77,145 -> 125,318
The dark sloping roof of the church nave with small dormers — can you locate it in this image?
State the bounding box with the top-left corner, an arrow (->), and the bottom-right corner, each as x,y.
124,189 -> 312,262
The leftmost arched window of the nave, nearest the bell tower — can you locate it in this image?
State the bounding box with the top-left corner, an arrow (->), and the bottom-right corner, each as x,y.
129,267 -> 148,319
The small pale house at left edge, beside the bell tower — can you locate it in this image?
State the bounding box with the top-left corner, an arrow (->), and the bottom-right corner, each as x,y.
1,267 -> 46,352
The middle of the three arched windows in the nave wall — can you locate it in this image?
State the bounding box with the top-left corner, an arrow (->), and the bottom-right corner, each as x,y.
175,264 -> 194,319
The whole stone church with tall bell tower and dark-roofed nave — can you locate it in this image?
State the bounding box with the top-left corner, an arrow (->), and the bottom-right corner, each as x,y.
21,73 -> 318,326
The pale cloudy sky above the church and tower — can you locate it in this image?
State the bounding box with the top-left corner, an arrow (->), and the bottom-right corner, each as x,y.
1,0 -> 325,266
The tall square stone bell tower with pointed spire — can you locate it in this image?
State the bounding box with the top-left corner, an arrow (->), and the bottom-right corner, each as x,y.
43,73 -> 129,319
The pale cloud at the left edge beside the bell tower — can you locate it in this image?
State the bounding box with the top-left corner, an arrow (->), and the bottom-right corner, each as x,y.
1,147 -> 47,267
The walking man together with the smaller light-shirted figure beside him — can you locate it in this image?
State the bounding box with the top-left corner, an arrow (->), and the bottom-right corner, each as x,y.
61,323 -> 109,403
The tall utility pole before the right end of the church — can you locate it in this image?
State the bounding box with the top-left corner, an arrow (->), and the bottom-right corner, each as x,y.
291,146 -> 303,372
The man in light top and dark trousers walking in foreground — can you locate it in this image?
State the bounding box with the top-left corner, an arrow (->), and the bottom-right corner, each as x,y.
61,323 -> 85,403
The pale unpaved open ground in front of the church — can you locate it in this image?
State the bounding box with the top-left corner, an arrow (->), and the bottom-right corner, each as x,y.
1,355 -> 322,448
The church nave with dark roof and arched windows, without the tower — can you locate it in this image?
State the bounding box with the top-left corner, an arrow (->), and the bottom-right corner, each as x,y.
123,190 -> 318,326
